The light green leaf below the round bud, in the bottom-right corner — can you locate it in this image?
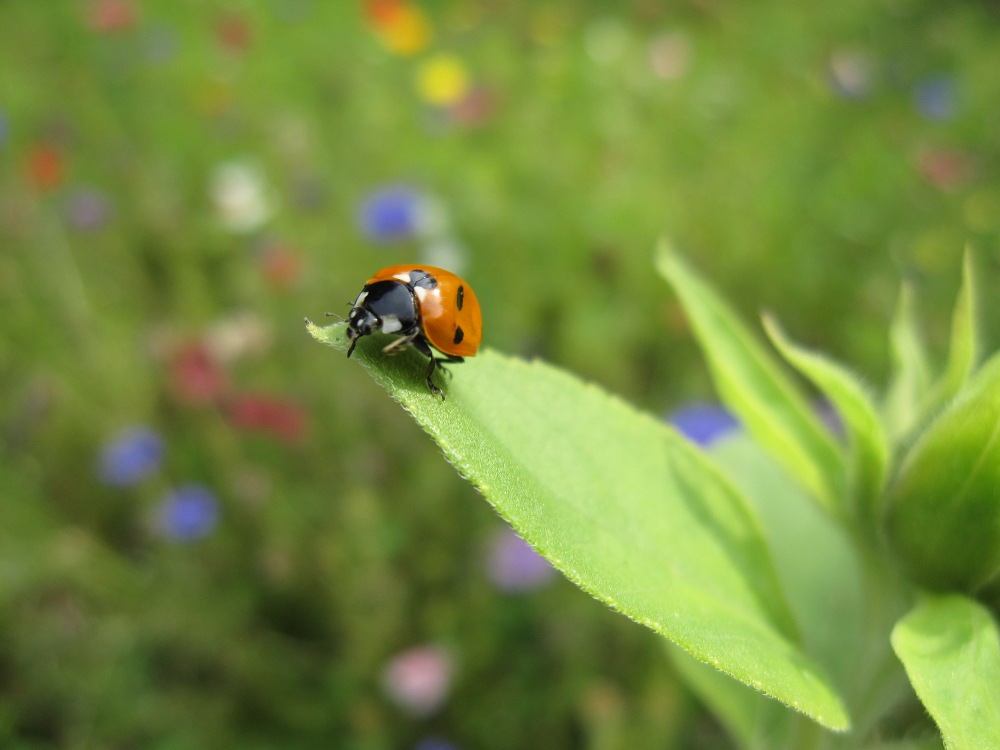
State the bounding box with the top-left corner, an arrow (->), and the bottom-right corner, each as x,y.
892,594 -> 1000,750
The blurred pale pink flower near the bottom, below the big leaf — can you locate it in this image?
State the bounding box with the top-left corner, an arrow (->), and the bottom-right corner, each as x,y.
382,646 -> 453,717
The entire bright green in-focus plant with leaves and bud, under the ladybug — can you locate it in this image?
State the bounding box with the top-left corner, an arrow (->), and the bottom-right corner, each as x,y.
318,247 -> 1000,748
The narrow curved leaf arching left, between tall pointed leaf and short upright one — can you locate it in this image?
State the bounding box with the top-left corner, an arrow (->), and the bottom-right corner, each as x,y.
764,316 -> 889,527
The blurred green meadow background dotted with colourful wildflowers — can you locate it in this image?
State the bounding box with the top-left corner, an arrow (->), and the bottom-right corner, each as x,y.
0,0 -> 1000,750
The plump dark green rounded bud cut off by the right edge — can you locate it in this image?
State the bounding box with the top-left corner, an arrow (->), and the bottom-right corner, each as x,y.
886,354 -> 1000,590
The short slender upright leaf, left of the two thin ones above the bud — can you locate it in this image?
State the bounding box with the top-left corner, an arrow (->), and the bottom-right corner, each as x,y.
882,283 -> 930,442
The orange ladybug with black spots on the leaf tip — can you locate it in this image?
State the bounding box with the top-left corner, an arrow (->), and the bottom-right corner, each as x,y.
347,265 -> 483,401
